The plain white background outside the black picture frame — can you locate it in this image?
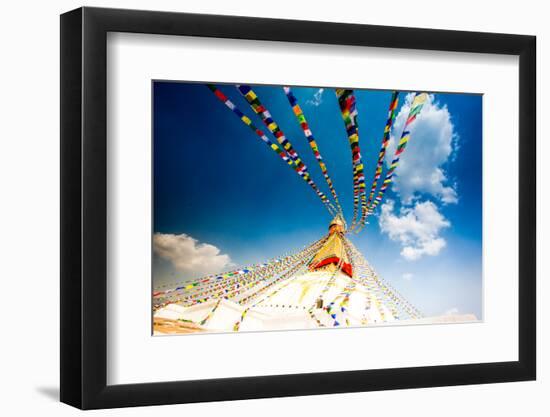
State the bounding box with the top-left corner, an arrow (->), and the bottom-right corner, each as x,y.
0,0 -> 550,416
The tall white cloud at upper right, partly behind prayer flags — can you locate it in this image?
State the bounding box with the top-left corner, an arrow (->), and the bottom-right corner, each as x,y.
386,93 -> 458,204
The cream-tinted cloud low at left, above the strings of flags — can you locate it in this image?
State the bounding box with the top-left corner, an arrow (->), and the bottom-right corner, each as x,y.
153,233 -> 233,274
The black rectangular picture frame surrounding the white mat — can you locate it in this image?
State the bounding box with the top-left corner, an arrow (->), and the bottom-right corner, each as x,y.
60,7 -> 536,409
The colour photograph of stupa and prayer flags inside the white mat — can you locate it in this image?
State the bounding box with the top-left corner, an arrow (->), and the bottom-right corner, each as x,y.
151,80 -> 484,335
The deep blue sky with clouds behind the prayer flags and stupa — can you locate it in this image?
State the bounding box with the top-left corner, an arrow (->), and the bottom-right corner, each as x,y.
153,81 -> 482,318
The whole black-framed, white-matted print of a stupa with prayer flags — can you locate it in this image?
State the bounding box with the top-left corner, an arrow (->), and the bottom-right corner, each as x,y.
61,8 -> 536,409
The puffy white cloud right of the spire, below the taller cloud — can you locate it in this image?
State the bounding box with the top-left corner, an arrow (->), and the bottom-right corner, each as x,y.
378,200 -> 451,261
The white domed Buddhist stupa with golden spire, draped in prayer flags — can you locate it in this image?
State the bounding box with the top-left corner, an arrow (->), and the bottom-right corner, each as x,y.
154,217 -> 475,334
